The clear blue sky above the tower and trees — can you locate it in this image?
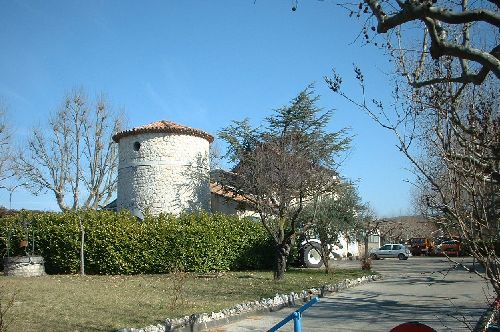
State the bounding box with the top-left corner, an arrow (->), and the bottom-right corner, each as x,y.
0,0 -> 411,216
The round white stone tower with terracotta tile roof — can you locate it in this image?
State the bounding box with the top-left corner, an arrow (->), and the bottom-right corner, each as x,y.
113,121 -> 214,218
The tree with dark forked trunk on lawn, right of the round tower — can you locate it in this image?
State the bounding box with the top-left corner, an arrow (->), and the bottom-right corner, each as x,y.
219,87 -> 350,280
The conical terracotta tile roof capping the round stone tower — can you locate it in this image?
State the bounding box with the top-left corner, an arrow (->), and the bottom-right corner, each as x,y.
113,120 -> 214,143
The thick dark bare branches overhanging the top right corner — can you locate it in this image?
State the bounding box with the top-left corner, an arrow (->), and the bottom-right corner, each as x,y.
328,0 -> 500,87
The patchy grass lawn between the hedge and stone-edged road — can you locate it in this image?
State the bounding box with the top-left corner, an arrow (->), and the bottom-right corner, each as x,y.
0,269 -> 369,331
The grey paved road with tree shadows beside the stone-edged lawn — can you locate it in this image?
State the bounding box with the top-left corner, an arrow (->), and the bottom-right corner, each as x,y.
205,257 -> 492,332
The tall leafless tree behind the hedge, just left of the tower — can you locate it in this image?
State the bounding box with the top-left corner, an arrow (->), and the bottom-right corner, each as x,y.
15,91 -> 122,210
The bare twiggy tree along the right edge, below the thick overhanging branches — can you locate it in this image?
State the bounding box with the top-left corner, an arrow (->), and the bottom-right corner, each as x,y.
327,63 -> 500,294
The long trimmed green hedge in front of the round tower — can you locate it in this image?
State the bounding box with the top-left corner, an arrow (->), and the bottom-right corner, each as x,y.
0,211 -> 274,274
